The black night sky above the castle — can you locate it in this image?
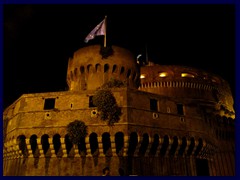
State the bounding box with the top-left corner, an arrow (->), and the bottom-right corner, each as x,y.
3,4 -> 235,108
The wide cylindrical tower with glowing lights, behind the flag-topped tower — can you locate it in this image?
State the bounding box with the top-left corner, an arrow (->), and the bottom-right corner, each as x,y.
139,63 -> 235,119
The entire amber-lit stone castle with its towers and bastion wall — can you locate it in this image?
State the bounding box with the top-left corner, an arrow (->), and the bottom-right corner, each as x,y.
3,45 -> 235,176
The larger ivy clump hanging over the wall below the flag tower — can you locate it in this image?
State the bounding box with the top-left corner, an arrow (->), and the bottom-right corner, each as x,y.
93,79 -> 126,126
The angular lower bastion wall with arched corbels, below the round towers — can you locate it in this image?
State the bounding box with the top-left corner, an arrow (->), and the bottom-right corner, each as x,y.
3,88 -> 235,176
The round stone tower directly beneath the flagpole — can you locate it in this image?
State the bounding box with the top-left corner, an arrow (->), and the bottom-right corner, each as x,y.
67,45 -> 140,91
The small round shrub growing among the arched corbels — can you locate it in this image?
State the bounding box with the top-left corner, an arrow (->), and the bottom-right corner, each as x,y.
67,120 -> 87,144
